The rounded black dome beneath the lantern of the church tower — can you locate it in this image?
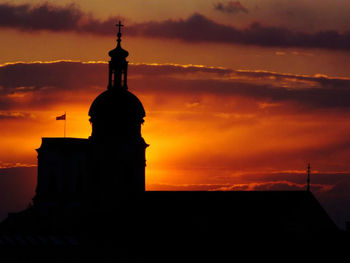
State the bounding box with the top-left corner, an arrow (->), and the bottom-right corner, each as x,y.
89,89 -> 145,123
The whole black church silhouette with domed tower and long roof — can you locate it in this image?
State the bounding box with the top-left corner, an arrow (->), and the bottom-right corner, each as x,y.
0,22 -> 348,262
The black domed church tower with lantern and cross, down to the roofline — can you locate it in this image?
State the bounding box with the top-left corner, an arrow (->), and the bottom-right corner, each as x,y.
89,21 -> 148,200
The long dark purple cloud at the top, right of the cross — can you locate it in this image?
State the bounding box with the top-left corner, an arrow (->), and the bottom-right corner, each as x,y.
127,14 -> 350,50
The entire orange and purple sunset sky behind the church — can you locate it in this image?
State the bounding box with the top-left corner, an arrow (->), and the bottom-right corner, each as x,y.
0,0 -> 350,227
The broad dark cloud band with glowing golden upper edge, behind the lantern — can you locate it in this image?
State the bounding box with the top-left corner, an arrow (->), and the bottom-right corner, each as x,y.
0,61 -> 350,110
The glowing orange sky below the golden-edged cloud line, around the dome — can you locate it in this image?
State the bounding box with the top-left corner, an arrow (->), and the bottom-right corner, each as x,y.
0,61 -> 350,189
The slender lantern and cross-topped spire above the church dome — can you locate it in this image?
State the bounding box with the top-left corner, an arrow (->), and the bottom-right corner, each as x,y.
108,21 -> 129,90
